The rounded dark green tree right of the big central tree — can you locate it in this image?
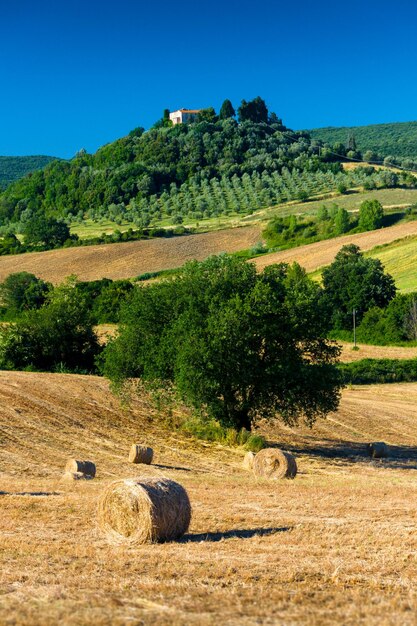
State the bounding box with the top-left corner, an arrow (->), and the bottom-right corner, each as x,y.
323,244 -> 396,329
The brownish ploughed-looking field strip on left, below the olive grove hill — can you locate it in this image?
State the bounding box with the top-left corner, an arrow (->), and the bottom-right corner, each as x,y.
0,226 -> 260,284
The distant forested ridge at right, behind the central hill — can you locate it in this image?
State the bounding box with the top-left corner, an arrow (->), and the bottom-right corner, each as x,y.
308,122 -> 417,160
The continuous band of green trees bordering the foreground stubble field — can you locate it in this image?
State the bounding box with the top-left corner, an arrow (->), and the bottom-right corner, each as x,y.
0,245 -> 417,430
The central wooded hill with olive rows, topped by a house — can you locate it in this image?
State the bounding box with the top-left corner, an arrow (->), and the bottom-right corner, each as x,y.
0,97 -> 414,247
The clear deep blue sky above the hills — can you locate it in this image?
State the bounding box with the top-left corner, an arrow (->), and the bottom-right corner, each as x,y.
0,0 -> 417,158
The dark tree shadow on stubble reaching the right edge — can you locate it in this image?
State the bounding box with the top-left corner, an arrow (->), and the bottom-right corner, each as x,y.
282,439 -> 417,470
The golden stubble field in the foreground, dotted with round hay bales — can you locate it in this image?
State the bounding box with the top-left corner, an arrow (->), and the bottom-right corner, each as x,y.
0,372 -> 417,626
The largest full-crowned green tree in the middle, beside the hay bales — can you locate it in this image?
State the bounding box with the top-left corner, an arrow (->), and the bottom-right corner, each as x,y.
104,256 -> 340,429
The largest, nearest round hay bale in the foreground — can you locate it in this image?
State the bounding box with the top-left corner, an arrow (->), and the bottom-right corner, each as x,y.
97,478 -> 191,544
